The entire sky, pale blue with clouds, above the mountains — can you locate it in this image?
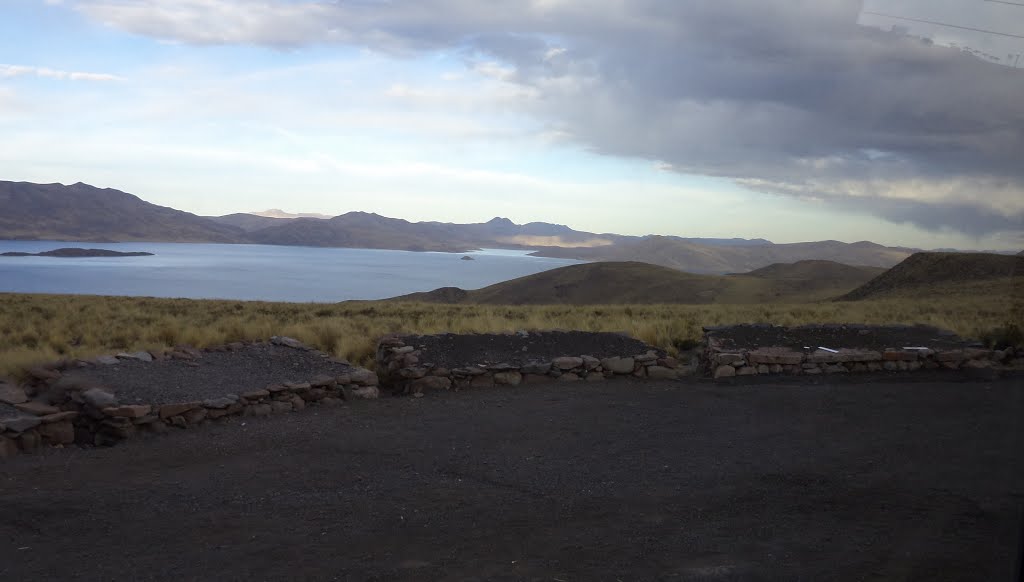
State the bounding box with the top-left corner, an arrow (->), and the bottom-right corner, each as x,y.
0,0 -> 1024,250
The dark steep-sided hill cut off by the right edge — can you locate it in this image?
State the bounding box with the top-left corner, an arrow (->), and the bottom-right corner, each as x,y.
841,253 -> 1024,301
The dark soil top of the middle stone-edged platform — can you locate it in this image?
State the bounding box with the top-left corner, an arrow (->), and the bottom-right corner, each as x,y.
402,331 -> 664,368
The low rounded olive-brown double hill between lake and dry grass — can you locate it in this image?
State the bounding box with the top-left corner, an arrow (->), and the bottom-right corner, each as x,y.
392,261 -> 884,305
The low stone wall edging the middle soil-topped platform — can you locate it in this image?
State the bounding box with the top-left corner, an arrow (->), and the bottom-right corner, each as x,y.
377,336 -> 695,397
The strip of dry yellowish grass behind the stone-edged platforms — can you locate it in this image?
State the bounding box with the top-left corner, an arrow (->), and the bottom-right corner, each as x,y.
0,294 -> 1024,376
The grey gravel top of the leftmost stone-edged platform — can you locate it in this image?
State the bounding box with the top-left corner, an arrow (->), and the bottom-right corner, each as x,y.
67,343 -> 352,404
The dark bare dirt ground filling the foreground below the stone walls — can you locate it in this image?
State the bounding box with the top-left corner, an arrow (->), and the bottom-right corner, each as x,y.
0,375 -> 1024,582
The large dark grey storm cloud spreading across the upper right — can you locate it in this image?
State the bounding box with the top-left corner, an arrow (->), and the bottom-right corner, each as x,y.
82,0 -> 1024,235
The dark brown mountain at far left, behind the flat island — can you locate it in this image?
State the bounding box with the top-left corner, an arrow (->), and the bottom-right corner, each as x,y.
0,181 -> 246,243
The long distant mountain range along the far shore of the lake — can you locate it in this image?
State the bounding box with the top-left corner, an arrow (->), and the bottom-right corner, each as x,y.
0,181 -> 1011,274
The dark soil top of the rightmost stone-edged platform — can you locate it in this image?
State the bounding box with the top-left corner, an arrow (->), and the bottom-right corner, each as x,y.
707,324 -> 970,350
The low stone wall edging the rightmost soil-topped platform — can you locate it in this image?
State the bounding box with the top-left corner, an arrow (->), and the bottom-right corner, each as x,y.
701,326 -> 1024,378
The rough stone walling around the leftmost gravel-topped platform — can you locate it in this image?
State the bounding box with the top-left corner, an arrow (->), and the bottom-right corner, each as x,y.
0,338 -> 379,459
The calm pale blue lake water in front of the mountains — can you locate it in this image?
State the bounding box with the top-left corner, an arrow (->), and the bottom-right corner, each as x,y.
0,241 -> 578,302
